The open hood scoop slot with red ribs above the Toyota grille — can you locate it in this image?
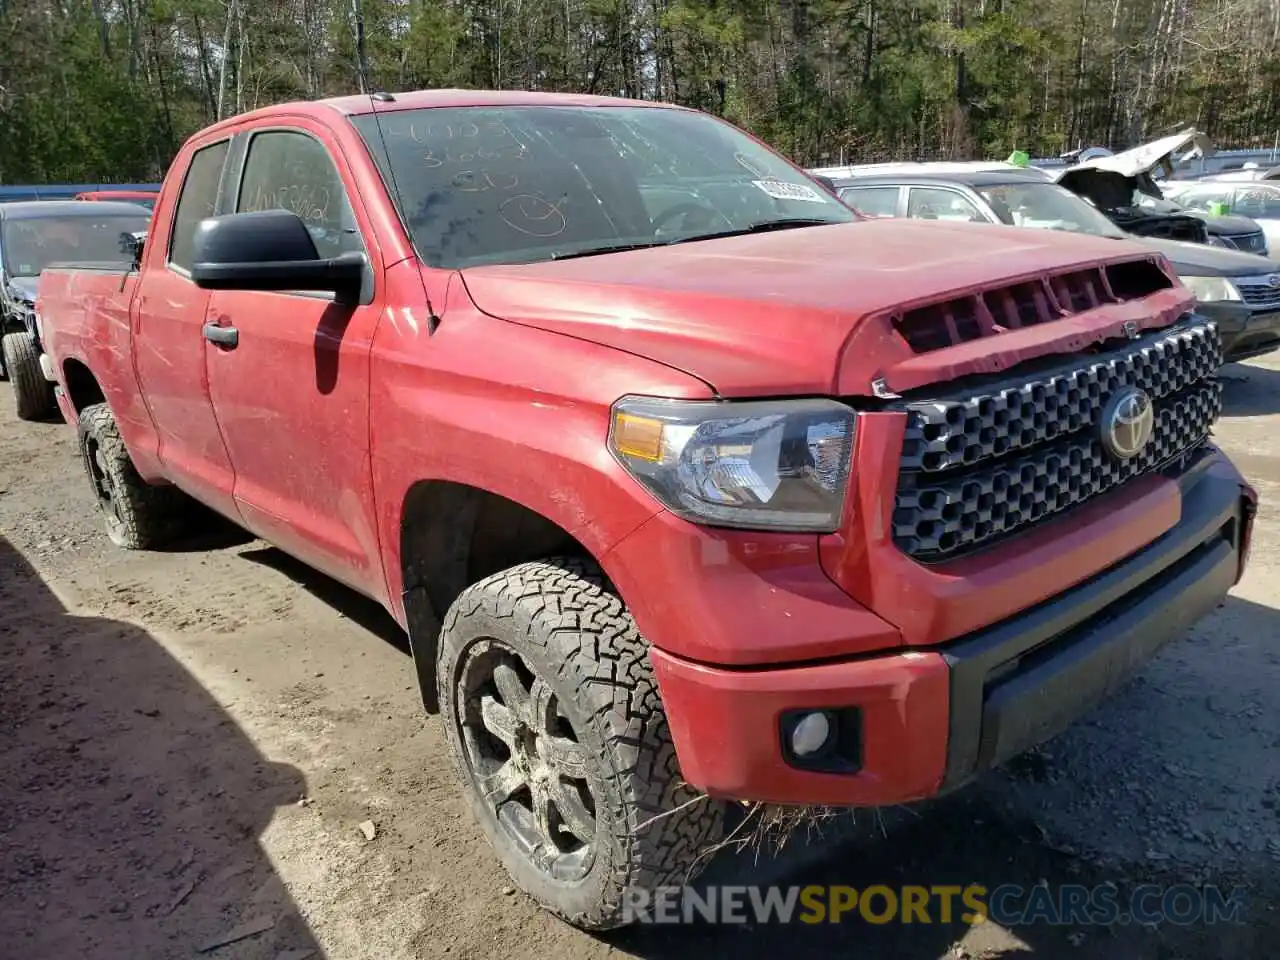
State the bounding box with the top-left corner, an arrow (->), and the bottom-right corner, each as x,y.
892,260 -> 1172,353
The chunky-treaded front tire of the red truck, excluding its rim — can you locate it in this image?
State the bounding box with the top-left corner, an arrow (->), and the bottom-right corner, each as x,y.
436,558 -> 724,929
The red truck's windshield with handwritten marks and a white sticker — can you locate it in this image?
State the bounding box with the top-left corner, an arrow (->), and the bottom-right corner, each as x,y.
352,106 -> 858,269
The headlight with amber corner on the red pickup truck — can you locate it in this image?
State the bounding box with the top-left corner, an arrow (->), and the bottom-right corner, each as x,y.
609,397 -> 855,532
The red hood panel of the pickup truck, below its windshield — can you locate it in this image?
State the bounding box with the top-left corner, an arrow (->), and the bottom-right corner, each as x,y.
462,219 -> 1172,397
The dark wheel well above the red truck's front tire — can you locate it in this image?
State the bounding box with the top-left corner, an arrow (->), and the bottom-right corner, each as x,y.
401,480 -> 591,713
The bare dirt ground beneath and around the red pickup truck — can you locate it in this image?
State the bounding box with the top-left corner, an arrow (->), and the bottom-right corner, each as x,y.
0,358 -> 1280,960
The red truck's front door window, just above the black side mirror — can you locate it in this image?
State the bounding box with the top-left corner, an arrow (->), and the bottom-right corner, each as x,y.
236,131 -> 365,257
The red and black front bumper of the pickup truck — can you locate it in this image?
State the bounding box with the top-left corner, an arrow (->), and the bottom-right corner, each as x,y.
650,451 -> 1257,806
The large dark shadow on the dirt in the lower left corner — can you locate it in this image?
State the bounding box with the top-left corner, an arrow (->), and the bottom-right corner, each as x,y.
0,538 -> 321,960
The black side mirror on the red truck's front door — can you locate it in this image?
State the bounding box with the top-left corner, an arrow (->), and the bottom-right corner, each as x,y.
191,210 -> 367,303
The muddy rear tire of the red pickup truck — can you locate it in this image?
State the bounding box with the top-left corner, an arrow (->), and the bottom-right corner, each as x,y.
78,403 -> 192,550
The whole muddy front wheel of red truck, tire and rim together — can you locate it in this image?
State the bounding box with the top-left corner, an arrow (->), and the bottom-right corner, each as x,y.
436,559 -> 723,929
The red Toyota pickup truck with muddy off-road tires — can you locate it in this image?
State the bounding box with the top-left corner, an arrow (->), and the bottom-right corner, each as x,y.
38,91 -> 1256,928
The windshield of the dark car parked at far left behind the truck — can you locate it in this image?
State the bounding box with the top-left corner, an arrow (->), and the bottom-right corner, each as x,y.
0,211 -> 150,276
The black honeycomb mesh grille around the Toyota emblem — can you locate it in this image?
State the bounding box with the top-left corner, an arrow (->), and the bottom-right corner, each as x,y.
893,321 -> 1222,561
